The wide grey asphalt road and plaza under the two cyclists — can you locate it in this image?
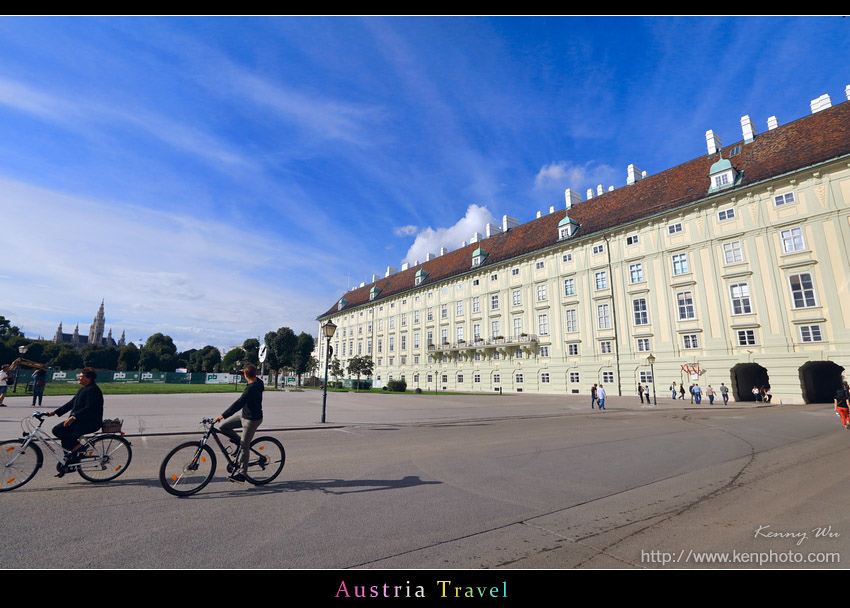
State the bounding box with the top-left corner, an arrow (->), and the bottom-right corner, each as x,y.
0,392 -> 850,569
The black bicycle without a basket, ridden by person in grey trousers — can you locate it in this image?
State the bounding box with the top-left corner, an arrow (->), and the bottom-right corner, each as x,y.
159,418 -> 286,496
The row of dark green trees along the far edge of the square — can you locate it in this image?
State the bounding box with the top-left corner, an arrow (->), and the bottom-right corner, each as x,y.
0,316 -> 318,383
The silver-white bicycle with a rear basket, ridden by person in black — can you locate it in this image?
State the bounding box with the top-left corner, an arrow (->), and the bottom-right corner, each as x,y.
0,412 -> 133,492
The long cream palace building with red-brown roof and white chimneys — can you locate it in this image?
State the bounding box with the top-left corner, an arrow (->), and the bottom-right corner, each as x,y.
317,85 -> 850,403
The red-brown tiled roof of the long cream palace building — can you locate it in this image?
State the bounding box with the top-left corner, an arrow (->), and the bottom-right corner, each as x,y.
319,102 -> 850,318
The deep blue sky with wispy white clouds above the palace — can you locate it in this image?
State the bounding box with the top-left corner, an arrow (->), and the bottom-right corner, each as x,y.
0,17 -> 850,350
